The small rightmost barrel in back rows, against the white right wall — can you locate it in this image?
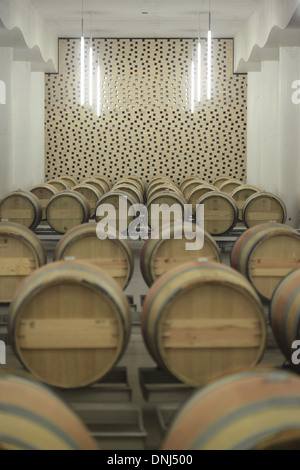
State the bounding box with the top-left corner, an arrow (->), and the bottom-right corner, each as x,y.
242,192 -> 287,228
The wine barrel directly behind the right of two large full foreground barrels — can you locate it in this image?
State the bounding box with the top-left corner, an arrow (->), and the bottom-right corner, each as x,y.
140,223 -> 221,287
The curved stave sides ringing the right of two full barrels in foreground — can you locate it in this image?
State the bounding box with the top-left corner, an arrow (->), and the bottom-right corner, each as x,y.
141,261 -> 267,388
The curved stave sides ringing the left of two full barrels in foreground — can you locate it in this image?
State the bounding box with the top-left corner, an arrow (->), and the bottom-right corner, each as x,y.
8,261 -> 131,389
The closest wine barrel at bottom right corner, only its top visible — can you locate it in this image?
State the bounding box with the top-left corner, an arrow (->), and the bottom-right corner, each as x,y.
162,369 -> 300,451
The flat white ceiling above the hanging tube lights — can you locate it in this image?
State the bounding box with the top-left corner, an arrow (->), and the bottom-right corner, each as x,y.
31,0 -> 261,38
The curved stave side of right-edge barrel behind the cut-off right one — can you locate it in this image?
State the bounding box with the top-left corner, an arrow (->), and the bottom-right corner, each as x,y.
230,223 -> 299,301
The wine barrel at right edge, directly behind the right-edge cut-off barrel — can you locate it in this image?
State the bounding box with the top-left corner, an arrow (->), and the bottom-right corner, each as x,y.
231,224 -> 300,300
